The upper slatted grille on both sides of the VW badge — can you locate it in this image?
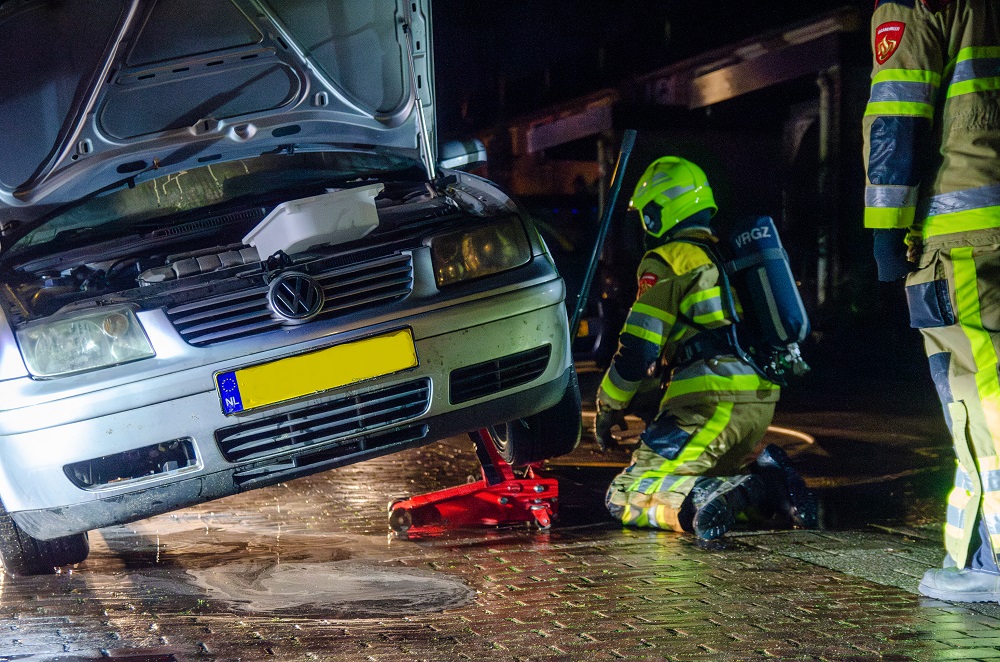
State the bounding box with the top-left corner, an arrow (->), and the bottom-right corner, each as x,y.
167,253 -> 413,346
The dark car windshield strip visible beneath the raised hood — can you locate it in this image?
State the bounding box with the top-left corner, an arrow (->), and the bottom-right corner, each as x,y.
9,152 -> 419,255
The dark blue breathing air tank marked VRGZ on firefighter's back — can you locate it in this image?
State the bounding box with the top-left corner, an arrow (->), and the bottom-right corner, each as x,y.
723,216 -> 809,383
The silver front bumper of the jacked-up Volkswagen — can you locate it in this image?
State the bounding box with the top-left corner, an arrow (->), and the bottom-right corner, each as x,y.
0,280 -> 572,539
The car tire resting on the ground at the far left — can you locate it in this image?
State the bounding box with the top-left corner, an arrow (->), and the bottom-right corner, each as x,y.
0,506 -> 90,575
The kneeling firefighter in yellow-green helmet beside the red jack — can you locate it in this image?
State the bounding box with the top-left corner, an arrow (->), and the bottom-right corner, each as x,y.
595,156 -> 818,540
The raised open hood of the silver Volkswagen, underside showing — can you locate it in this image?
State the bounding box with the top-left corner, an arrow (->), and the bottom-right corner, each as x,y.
0,0 -> 435,231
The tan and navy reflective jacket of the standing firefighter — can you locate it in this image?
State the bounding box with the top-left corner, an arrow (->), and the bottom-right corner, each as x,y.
863,0 -> 1000,247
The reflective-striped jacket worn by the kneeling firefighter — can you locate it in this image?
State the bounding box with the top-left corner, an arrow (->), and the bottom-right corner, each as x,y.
597,229 -> 780,409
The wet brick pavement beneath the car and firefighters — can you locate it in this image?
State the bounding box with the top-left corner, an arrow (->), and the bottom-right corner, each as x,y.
0,366 -> 1000,661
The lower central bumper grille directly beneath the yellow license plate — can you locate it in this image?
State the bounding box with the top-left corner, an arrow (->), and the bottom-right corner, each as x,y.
215,379 -> 431,462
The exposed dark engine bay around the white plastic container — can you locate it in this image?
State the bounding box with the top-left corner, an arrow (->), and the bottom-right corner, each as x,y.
2,183 -> 457,325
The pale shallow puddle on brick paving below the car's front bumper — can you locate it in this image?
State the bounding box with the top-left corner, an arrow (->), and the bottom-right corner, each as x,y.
74,525 -> 476,619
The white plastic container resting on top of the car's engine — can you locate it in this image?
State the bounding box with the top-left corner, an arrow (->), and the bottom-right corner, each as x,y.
243,184 -> 383,260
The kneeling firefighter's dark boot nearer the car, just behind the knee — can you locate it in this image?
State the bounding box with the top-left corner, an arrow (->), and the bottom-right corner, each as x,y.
691,474 -> 766,540
